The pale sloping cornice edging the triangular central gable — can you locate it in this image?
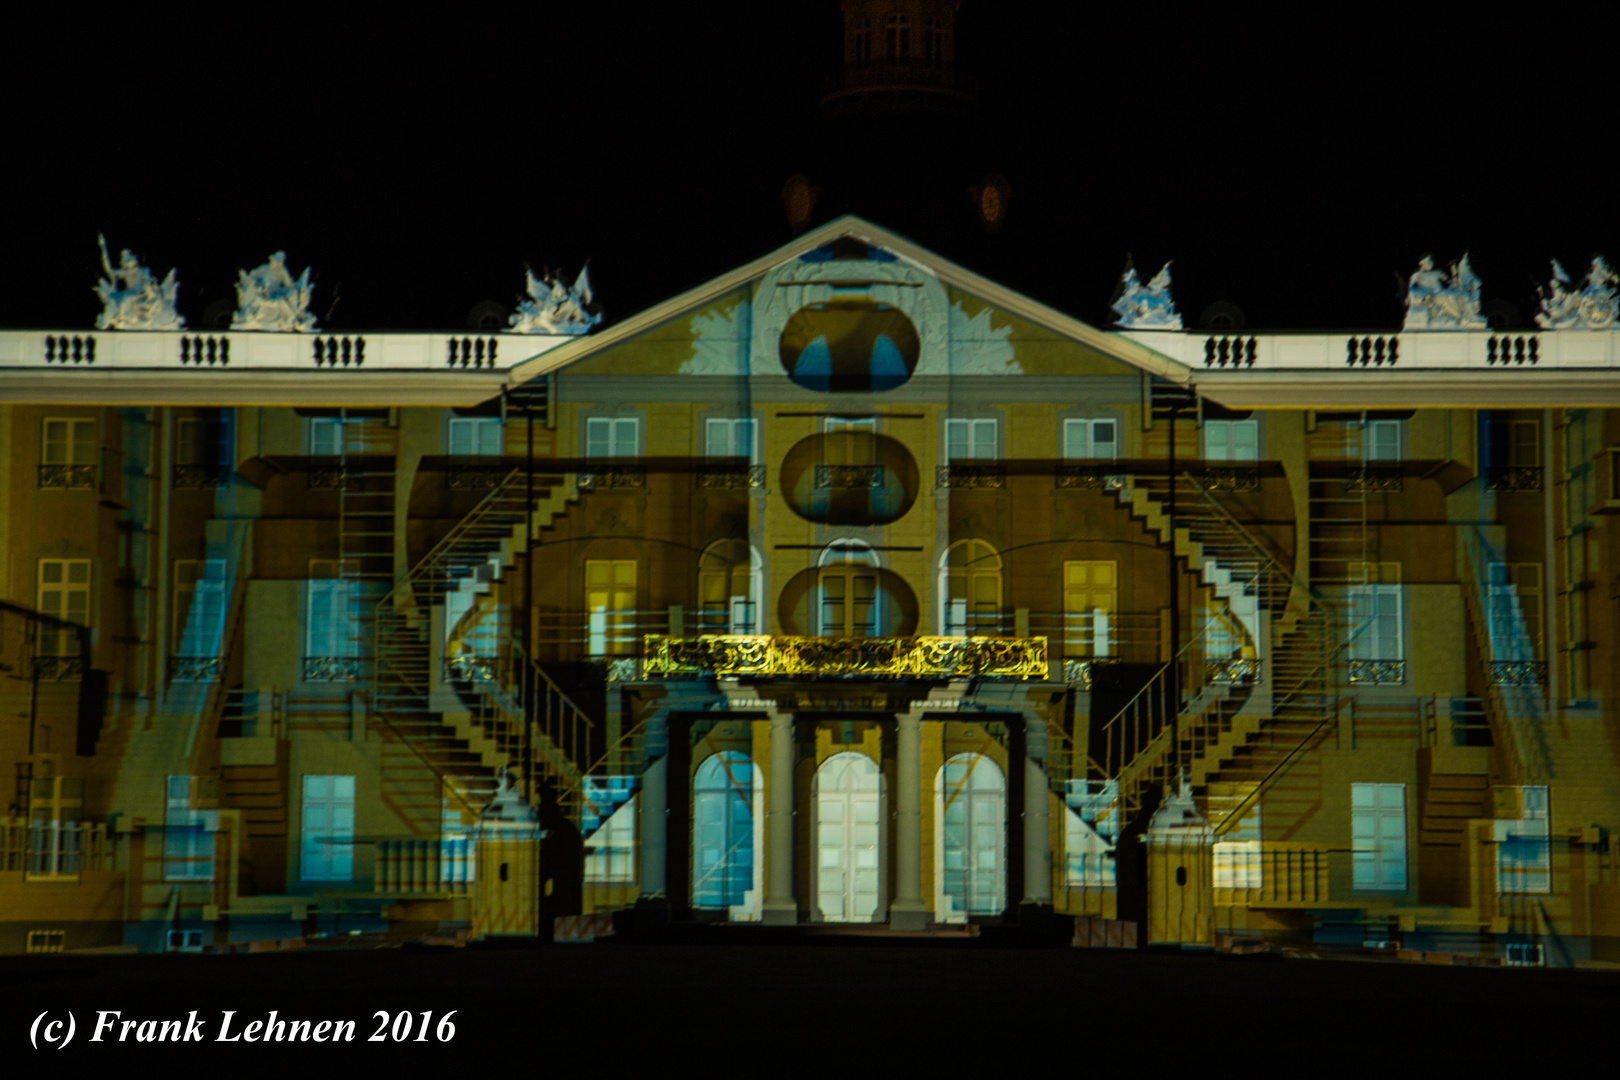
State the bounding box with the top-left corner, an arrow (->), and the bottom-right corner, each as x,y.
507,214 -> 1192,385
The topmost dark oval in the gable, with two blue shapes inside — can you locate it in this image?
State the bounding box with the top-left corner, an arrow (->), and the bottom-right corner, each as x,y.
779,298 -> 920,393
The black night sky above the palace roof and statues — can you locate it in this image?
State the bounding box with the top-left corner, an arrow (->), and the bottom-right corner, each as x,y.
0,0 -> 1620,329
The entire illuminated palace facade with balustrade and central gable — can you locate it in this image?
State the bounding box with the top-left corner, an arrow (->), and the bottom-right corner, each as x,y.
0,217 -> 1620,965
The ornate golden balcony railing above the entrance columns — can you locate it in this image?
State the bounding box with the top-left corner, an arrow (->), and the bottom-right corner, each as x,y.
643,633 -> 1047,678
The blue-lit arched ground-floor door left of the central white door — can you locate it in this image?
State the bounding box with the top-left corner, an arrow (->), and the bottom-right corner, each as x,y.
692,750 -> 765,918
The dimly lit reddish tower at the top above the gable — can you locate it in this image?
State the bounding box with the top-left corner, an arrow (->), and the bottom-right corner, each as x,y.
821,0 -> 974,113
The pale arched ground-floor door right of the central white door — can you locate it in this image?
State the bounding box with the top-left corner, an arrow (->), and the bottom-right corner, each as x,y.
933,753 -> 1008,923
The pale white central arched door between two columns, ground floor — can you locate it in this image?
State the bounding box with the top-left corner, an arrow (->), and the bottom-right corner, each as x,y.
815,753 -> 885,923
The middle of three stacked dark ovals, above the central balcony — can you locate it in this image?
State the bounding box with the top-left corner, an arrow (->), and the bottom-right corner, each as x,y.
781,431 -> 919,525
